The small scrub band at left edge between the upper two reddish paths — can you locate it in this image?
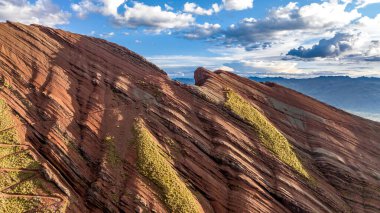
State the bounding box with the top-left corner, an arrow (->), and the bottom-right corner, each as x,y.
0,152 -> 41,169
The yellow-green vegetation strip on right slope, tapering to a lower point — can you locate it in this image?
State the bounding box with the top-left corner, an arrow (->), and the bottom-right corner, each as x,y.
224,90 -> 310,178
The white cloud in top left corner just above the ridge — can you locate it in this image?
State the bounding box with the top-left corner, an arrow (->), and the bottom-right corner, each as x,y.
0,0 -> 70,27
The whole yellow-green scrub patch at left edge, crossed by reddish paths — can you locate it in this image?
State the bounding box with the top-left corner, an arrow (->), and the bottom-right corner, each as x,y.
0,99 -> 55,213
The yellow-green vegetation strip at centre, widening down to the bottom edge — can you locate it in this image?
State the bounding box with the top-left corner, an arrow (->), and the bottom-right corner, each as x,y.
134,120 -> 200,213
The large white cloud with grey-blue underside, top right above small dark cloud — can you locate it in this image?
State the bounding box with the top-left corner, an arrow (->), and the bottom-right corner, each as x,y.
225,1 -> 361,50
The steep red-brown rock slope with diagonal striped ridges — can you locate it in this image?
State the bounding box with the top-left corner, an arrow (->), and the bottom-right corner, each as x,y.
0,23 -> 380,213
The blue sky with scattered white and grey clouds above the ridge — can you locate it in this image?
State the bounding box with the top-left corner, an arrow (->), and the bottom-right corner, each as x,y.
0,0 -> 380,78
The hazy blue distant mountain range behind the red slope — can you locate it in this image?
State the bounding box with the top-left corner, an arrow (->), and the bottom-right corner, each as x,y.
175,76 -> 380,121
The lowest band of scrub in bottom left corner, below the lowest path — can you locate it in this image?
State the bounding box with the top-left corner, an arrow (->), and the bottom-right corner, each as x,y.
0,197 -> 41,213
